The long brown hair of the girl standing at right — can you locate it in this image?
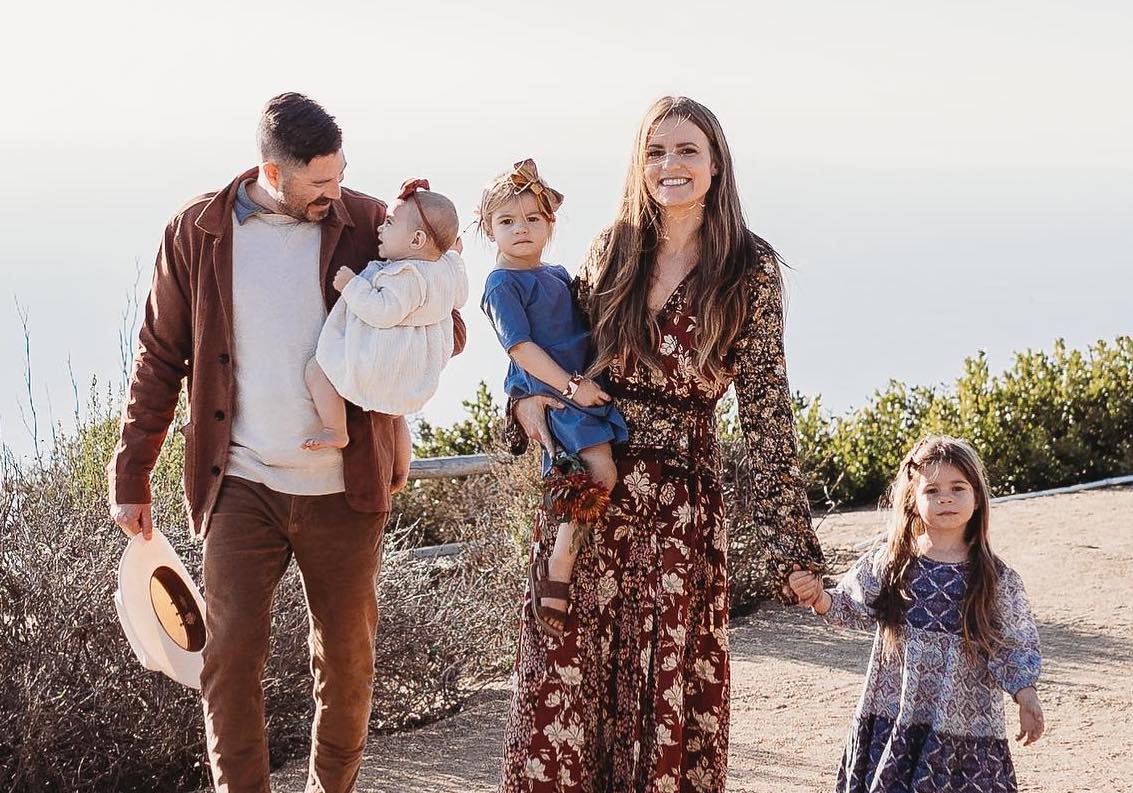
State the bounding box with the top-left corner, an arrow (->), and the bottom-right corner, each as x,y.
872,435 -> 1002,657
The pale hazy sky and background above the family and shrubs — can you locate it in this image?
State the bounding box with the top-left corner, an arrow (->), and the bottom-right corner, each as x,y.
0,0 -> 1133,462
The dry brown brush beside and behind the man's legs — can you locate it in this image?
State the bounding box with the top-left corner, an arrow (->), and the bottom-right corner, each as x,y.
0,426 -> 530,793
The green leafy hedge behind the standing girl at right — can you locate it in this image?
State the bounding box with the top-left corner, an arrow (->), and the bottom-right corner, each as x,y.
815,336 -> 1133,504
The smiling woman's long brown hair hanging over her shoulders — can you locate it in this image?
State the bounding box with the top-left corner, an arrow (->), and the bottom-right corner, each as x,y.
590,96 -> 777,381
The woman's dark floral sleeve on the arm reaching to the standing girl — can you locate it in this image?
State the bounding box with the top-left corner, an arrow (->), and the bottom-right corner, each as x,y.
733,256 -> 824,597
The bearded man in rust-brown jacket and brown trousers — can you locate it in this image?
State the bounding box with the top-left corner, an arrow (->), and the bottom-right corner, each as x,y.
108,93 -> 465,793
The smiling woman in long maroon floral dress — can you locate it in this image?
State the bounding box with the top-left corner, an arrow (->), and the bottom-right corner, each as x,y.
503,96 -> 821,793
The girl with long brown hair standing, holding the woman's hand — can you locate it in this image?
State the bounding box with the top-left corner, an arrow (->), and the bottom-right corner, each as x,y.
789,435 -> 1043,793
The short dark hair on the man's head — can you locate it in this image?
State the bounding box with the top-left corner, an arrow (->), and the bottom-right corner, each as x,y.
256,92 -> 342,165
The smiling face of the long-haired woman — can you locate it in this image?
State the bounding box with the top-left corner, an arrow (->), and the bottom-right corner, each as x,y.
645,116 -> 716,208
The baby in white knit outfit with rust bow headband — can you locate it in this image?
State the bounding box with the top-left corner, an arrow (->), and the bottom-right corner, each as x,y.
303,179 -> 468,454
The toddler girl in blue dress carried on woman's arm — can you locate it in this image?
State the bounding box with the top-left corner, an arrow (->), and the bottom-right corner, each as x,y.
479,160 -> 629,637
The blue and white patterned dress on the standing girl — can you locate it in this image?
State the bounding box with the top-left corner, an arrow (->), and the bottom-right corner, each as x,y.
826,549 -> 1041,793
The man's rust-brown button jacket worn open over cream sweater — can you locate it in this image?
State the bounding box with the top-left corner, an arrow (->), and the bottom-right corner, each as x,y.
107,169 -> 466,536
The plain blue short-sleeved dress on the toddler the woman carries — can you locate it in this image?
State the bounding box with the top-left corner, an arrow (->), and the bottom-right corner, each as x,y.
480,264 -> 629,470
